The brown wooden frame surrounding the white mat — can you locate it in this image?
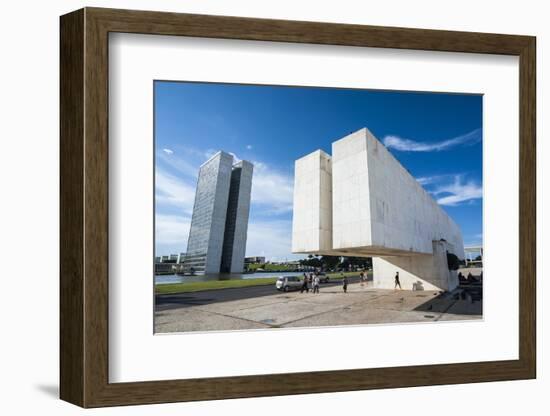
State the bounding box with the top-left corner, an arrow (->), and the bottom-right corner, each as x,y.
60,8 -> 536,407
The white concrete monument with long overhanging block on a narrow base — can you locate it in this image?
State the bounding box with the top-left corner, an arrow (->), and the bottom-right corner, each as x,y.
292,128 -> 464,290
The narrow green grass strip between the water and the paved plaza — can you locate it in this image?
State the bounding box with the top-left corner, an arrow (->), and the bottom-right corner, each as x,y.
155,272 -> 372,295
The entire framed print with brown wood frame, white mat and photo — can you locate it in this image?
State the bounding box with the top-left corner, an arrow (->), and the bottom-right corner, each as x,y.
60,8 -> 536,407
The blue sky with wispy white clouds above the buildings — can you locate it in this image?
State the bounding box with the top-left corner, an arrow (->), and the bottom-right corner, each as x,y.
154,81 -> 482,261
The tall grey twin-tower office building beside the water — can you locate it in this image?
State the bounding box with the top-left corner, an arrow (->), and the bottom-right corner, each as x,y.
184,151 -> 253,274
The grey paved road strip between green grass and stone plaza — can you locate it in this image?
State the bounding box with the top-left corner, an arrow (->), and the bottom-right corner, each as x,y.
155,276 -> 359,311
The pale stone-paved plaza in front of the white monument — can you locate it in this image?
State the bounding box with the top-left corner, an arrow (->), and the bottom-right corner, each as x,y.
155,282 -> 482,333
